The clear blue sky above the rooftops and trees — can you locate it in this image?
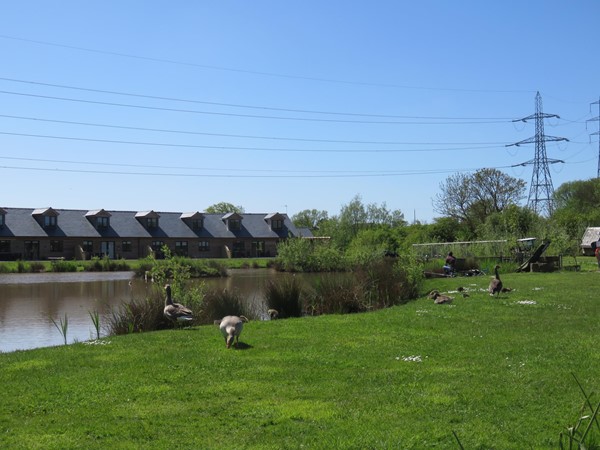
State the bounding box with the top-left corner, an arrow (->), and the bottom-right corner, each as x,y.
0,0 -> 600,222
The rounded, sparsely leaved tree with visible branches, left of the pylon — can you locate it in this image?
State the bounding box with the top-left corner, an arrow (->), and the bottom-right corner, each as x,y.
433,169 -> 526,236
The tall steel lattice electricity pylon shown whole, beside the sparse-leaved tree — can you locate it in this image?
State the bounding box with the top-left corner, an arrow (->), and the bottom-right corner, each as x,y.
507,92 -> 568,216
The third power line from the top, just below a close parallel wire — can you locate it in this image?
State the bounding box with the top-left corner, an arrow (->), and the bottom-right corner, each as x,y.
0,90 -> 506,125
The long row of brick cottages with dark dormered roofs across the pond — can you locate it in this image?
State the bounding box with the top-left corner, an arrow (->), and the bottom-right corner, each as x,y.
0,208 -> 309,261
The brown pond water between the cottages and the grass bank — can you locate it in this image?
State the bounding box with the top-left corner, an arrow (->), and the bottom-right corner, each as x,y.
0,269 -> 300,352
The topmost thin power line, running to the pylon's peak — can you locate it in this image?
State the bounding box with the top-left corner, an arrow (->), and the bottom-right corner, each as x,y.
0,34 -> 533,93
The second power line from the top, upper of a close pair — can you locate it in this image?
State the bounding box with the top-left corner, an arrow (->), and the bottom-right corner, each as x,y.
0,77 -> 511,123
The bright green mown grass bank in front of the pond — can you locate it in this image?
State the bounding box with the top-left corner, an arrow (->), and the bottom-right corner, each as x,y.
0,272 -> 600,450
